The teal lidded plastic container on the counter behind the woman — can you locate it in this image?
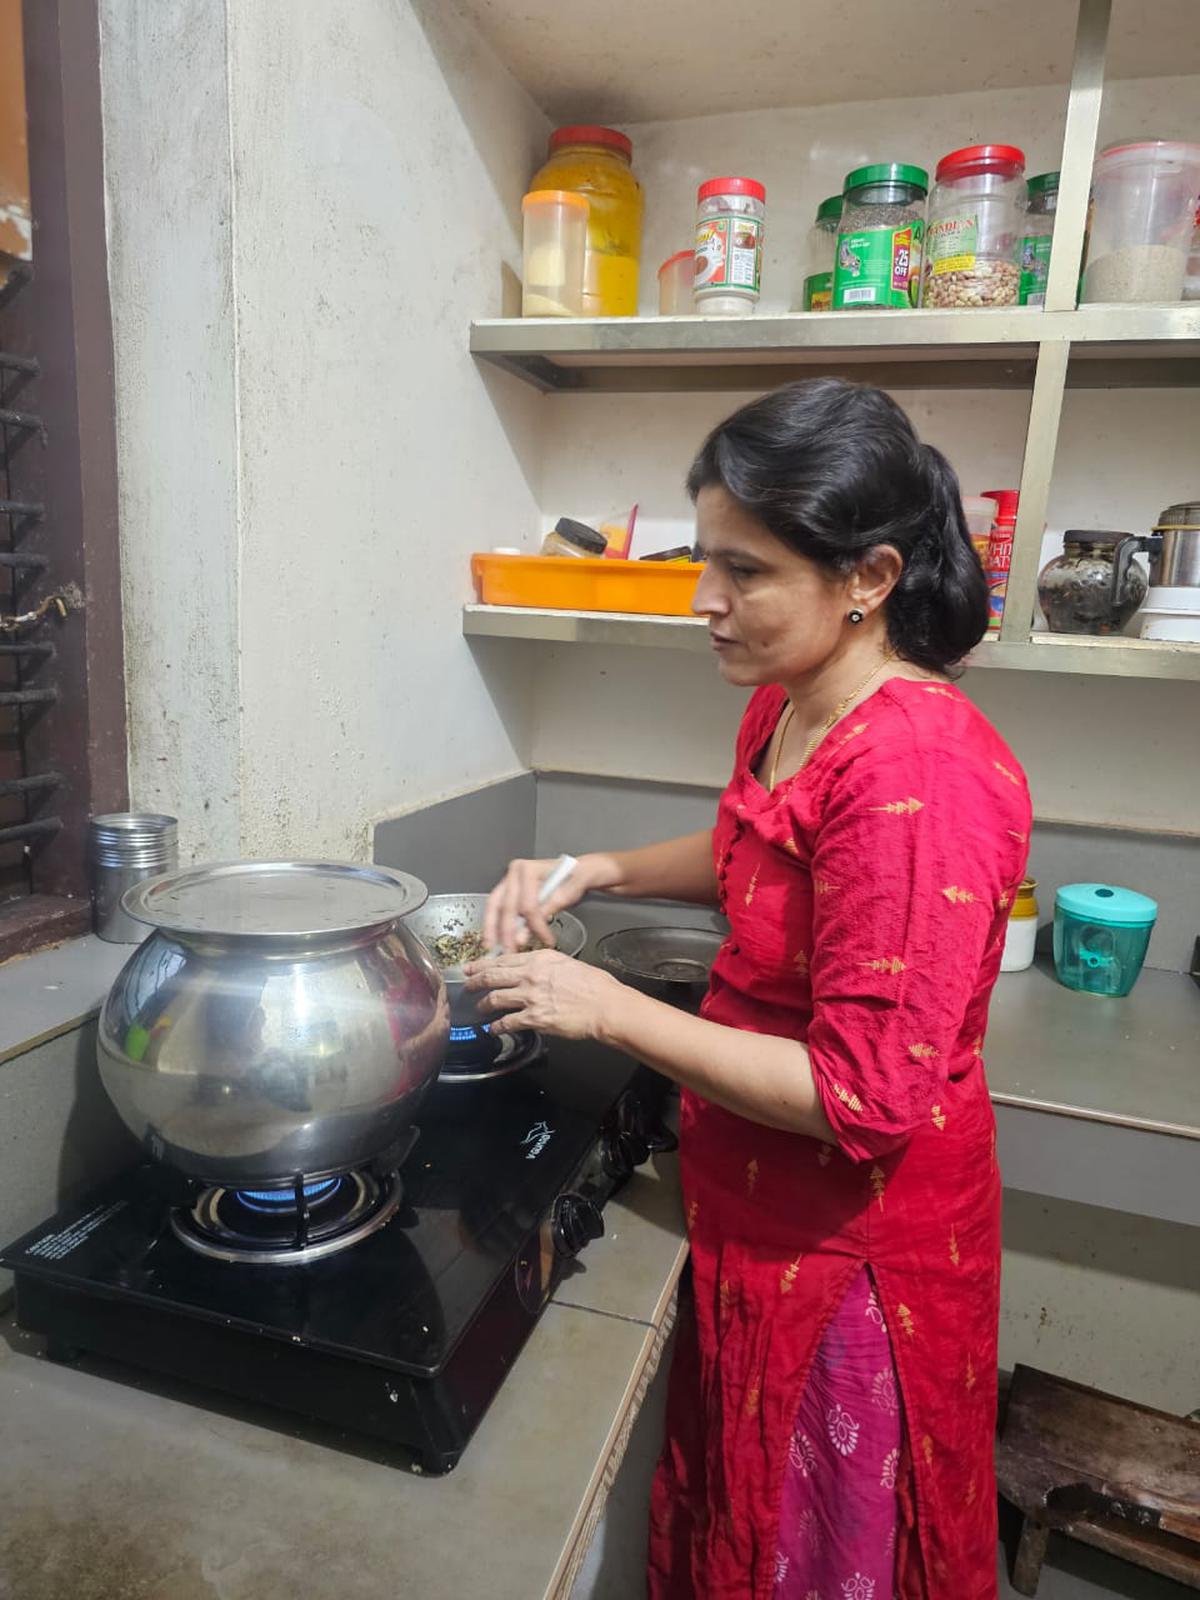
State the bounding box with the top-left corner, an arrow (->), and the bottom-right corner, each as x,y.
1054,883 -> 1158,995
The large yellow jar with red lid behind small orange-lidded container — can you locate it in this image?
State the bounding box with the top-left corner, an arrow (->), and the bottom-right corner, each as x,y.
530,125 -> 645,317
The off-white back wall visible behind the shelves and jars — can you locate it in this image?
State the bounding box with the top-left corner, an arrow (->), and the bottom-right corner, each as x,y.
526,78 -> 1200,832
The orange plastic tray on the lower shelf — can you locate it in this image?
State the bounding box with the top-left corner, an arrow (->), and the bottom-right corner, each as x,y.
470,555 -> 704,616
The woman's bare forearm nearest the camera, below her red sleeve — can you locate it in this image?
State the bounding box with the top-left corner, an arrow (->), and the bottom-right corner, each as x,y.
600,989 -> 837,1144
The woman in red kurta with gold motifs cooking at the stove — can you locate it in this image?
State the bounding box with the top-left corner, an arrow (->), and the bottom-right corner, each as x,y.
472,379 -> 1030,1600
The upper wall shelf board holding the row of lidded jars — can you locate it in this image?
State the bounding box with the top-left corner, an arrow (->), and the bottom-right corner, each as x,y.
470,304 -> 1200,394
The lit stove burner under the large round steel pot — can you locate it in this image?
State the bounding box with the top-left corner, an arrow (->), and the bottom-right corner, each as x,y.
171,1171 -> 402,1266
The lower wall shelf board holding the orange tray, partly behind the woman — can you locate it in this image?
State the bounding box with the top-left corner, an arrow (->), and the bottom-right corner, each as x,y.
462,605 -> 1200,682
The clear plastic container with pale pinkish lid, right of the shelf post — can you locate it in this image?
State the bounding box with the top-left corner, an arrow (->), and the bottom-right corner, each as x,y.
1083,139 -> 1200,304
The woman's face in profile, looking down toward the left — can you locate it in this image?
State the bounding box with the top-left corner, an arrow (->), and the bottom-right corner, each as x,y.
691,486 -> 854,686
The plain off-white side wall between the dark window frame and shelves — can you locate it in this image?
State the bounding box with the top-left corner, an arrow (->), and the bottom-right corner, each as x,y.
102,0 -> 547,856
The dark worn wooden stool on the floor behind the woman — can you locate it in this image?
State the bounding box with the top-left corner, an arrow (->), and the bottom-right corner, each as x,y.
995,1366 -> 1200,1595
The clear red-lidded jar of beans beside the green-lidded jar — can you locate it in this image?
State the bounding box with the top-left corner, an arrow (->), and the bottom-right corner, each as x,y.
922,144 -> 1026,309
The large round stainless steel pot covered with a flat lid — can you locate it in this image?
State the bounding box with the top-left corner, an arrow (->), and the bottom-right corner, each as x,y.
98,861 -> 450,1187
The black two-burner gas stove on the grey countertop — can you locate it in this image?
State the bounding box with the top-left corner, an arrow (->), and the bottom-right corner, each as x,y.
0,1042 -> 674,1472
